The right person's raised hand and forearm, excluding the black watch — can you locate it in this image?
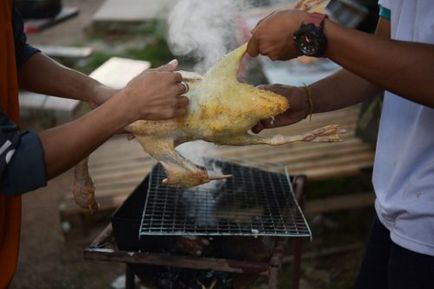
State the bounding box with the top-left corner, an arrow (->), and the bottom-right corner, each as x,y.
248,10 -> 434,107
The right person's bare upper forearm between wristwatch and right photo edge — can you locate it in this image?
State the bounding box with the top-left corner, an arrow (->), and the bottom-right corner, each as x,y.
325,21 -> 434,107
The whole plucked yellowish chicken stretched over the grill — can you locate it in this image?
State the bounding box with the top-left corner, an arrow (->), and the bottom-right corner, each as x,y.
73,45 -> 346,210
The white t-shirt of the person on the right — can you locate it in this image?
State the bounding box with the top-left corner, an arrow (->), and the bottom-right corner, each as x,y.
373,0 -> 434,256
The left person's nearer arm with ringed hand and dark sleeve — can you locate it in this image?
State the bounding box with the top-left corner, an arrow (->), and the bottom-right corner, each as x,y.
0,63 -> 188,194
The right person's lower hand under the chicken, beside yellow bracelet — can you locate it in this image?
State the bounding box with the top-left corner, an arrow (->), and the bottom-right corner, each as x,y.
252,84 -> 310,133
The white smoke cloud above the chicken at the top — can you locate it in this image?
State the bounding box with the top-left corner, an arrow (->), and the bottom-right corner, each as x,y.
168,0 -> 249,73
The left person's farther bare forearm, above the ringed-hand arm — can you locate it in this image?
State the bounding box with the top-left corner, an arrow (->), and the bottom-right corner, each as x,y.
19,53 -> 100,101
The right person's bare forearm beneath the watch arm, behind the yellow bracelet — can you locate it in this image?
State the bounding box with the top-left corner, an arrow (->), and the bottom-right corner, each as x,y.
310,69 -> 381,113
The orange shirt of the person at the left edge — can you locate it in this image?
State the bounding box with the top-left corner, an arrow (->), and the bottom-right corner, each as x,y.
0,0 -> 21,289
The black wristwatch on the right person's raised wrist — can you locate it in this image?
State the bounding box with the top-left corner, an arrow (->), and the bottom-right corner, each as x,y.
294,13 -> 327,57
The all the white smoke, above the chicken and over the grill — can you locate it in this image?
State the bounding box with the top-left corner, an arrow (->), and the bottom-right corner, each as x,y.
168,0 -> 291,225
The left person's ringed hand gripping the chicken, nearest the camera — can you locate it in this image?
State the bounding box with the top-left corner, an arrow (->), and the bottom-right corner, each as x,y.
122,60 -> 188,120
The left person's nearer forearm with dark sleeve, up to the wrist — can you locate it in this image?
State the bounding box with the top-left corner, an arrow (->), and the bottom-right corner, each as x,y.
0,95 -> 131,195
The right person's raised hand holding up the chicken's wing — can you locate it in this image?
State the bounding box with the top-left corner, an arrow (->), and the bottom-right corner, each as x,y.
247,10 -> 308,60
